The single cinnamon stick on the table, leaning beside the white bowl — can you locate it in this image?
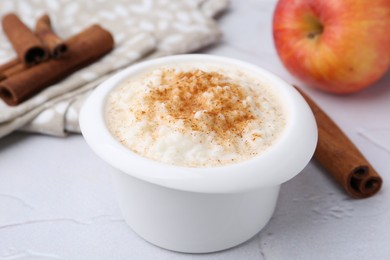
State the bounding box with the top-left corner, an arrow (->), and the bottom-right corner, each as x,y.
297,88 -> 382,199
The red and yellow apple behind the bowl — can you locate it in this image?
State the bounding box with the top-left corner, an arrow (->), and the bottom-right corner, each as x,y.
273,0 -> 390,94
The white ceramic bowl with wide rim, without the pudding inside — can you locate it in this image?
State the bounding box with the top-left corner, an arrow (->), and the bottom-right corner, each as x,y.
80,54 -> 317,253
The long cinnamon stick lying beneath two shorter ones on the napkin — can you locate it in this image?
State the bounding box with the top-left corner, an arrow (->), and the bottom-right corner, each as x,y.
0,25 -> 114,106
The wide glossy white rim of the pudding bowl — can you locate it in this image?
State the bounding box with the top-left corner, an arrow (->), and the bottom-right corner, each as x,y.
79,54 -> 317,193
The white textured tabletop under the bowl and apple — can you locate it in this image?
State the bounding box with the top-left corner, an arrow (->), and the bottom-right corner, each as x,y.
0,0 -> 390,260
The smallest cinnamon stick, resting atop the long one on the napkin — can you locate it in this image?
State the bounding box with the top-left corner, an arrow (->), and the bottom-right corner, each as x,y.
35,14 -> 68,59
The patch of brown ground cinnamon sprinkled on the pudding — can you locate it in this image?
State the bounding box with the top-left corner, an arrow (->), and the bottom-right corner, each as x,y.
136,69 -> 255,139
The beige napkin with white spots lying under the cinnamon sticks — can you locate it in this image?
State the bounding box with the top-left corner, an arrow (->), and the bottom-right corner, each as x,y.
0,0 -> 228,137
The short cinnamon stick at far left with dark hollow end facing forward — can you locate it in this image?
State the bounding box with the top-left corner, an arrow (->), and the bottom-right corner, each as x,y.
2,14 -> 48,66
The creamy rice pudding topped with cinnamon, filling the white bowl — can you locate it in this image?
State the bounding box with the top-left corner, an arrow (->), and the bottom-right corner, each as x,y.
105,63 -> 286,167
